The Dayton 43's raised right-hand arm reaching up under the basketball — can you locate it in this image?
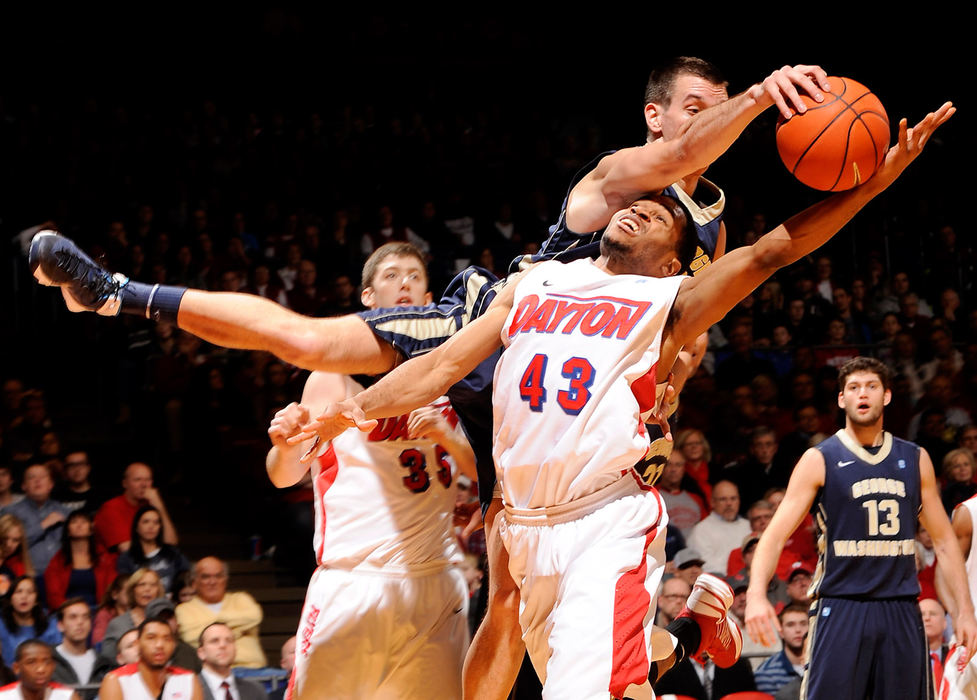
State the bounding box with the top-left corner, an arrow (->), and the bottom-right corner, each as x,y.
671,102 -> 955,352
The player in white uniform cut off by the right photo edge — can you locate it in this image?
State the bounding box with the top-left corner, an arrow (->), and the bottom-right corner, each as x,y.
936,486 -> 977,700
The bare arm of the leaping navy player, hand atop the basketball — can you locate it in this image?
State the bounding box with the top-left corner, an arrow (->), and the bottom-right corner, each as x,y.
567,66 -> 831,231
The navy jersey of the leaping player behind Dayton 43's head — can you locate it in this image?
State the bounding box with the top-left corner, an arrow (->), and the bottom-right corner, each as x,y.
509,151 -> 726,275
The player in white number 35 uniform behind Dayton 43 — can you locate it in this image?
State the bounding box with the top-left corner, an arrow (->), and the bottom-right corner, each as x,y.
268,243 -> 475,700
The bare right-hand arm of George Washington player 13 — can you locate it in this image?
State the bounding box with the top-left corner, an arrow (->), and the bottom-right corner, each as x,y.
919,448 -> 977,660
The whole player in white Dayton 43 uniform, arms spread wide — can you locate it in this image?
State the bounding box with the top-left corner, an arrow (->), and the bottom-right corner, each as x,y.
292,103 -> 953,699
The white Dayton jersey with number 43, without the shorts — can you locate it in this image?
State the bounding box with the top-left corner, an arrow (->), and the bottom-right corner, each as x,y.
493,260 -> 685,508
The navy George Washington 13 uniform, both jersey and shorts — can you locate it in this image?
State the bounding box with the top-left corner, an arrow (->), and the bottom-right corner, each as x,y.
801,430 -> 931,700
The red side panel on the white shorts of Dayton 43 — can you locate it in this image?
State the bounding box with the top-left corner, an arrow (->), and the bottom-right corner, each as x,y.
608,520 -> 661,698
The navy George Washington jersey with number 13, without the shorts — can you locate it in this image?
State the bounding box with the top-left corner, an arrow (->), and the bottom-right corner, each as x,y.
811,430 -> 921,599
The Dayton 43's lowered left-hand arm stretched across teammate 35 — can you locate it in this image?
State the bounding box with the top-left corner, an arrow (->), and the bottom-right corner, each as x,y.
288,275 -> 519,444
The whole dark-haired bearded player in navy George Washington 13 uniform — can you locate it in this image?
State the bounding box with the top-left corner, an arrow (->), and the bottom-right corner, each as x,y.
746,356 -> 977,700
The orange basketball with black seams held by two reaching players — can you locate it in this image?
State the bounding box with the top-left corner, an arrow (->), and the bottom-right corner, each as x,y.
777,77 -> 889,192
